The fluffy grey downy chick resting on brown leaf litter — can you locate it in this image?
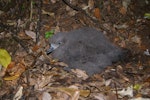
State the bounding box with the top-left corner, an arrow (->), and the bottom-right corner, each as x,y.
47,27 -> 122,75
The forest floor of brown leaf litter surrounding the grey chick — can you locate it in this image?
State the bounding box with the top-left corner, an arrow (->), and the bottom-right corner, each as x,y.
0,0 -> 150,100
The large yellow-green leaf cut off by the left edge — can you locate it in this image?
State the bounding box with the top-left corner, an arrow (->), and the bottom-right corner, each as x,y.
0,49 -> 11,68
